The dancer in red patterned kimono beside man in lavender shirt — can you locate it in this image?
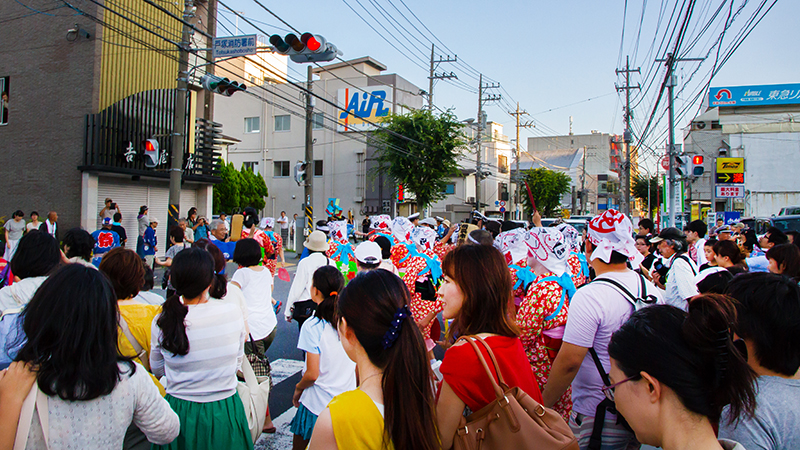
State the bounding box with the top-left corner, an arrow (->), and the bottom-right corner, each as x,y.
517,228 -> 576,420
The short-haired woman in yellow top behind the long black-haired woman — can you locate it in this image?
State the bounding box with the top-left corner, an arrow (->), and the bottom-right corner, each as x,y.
99,247 -> 166,450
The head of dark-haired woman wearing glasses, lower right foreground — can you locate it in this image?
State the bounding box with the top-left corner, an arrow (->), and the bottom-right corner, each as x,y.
603,294 -> 755,450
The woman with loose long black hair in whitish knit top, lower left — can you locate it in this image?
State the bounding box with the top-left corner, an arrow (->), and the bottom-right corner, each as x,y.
11,264 -> 180,450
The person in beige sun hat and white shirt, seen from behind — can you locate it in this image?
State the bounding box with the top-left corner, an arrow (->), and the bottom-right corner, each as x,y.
284,230 -> 333,327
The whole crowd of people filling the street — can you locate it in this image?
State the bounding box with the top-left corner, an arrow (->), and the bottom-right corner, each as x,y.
0,205 -> 800,450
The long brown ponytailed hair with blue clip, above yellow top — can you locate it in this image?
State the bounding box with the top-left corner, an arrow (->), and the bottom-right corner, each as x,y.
336,269 -> 441,450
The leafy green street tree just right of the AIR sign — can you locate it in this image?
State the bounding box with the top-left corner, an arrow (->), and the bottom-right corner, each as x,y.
373,109 -> 464,210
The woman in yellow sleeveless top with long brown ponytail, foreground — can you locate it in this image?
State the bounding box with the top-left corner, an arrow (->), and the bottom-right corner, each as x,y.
304,269 -> 441,450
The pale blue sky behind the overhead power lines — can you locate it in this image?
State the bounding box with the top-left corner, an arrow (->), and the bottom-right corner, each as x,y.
219,0 -> 800,165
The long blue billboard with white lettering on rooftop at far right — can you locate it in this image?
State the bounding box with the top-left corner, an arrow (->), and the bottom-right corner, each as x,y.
708,84 -> 800,108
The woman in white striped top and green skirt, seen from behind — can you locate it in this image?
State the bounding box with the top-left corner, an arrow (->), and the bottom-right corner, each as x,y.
150,248 -> 253,450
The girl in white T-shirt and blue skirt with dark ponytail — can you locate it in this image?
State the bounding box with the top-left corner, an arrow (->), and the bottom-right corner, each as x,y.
291,266 -> 356,450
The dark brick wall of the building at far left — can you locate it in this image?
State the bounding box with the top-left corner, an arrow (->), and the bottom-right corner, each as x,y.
0,1 -> 101,231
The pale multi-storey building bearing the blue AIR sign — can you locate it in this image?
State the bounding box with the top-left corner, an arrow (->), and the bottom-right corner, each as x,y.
214,57 -> 423,220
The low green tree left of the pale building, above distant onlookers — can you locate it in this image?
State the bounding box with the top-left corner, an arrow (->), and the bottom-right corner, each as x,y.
214,161 -> 269,214
